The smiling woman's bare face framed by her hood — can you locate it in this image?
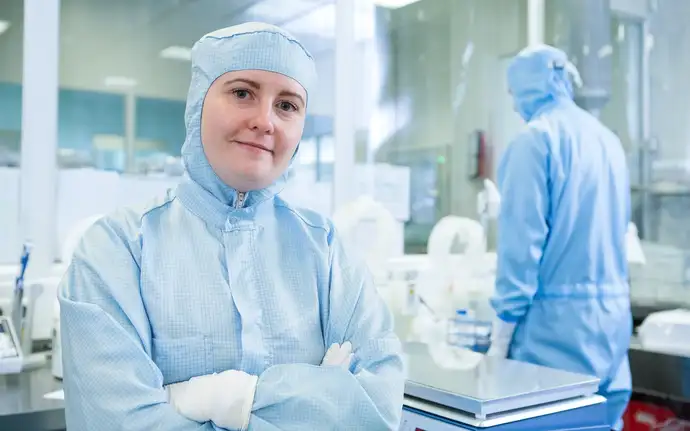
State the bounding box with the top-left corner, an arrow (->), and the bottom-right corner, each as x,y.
201,70 -> 307,192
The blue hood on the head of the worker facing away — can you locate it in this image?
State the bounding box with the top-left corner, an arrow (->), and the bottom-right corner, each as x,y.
508,45 -> 579,121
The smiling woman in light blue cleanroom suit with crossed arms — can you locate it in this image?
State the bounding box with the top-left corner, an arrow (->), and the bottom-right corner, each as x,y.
59,23 -> 404,431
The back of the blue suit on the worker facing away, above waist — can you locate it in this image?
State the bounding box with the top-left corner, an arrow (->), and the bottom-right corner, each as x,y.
530,103 -> 630,297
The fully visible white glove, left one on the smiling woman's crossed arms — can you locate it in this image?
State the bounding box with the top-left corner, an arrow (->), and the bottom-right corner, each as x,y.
166,370 -> 258,431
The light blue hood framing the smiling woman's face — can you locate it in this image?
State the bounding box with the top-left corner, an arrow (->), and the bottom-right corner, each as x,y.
182,23 -> 316,205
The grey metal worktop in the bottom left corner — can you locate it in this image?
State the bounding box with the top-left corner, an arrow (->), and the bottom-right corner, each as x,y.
0,367 -> 66,431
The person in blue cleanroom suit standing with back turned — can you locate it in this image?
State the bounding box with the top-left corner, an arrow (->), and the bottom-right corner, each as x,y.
490,46 -> 632,428
